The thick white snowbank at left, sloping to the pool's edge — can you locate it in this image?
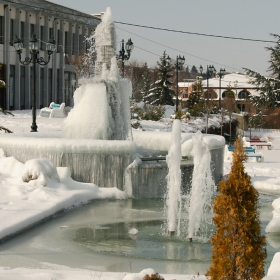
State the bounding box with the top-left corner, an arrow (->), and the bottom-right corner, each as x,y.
0,152 -> 127,239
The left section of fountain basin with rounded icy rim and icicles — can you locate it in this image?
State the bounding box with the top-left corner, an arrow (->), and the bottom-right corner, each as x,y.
0,132 -> 137,190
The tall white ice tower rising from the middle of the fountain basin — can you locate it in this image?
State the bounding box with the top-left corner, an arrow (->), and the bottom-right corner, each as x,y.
62,8 -> 132,140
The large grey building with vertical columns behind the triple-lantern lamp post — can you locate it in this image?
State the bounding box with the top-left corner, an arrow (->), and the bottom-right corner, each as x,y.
0,0 -> 100,110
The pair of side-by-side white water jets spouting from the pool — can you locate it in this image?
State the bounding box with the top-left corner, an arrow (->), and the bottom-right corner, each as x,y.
164,123 -> 216,242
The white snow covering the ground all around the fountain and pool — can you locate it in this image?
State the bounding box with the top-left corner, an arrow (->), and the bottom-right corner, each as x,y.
0,110 -> 280,280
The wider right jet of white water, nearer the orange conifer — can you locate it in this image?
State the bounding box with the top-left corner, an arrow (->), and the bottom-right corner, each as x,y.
188,131 -> 216,241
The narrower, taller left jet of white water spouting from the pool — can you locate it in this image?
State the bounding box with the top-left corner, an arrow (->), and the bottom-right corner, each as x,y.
165,120 -> 182,236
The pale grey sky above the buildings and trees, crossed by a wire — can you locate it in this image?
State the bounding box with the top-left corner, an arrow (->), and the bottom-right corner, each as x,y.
51,0 -> 280,75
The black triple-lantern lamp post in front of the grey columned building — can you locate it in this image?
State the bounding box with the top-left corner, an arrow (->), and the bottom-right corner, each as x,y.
13,34 -> 56,132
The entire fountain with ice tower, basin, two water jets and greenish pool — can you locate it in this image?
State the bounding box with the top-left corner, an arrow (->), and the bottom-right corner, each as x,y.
0,7 -> 280,274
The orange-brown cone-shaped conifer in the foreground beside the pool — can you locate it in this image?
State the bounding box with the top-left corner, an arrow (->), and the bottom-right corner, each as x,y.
206,138 -> 266,280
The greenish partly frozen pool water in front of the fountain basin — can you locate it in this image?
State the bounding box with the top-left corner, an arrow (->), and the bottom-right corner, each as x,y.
0,194 -> 280,274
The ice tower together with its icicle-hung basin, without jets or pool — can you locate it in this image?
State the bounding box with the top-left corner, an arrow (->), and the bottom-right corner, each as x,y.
0,8 -> 224,198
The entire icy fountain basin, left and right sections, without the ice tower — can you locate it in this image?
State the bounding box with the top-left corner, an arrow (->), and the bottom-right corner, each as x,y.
0,131 -> 224,198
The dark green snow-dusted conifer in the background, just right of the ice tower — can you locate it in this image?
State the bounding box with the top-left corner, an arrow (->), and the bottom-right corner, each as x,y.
144,51 -> 175,105
